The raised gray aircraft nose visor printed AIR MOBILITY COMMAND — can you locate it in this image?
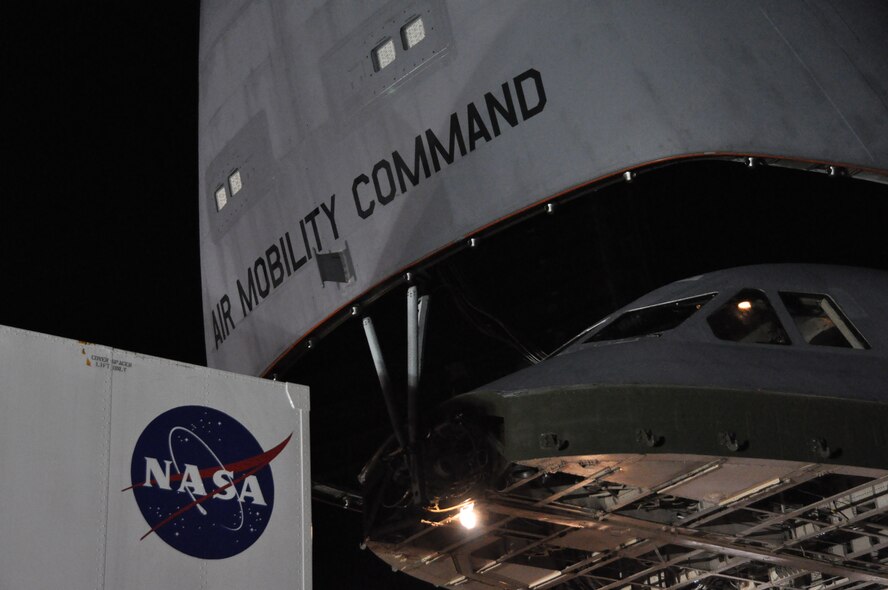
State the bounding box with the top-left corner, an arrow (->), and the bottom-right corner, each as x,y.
199,0 -> 888,374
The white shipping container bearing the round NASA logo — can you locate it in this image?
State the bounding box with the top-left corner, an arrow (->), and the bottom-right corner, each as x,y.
0,326 -> 311,590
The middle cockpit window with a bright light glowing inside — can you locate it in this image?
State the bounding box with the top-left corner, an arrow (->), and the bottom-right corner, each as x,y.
706,289 -> 790,344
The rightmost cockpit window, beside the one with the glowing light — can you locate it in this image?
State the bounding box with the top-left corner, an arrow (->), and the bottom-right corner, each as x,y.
780,292 -> 869,349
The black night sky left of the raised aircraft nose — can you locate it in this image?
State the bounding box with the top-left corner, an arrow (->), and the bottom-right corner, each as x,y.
0,2 -> 205,364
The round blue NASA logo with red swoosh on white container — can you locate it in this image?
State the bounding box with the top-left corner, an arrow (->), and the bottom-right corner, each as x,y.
123,406 -> 293,559
